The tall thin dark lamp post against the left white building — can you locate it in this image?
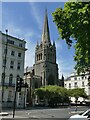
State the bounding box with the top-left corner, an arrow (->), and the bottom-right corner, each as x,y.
2,29 -> 8,102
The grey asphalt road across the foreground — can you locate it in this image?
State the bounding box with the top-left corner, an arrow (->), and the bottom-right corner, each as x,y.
1,107 -> 88,120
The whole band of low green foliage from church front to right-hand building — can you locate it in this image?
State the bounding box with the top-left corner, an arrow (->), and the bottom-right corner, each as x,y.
34,85 -> 88,106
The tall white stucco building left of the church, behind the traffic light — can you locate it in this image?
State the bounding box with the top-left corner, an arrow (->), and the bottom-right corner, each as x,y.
0,32 -> 26,107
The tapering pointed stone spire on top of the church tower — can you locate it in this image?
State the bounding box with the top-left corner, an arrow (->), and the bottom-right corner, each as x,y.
42,9 -> 50,44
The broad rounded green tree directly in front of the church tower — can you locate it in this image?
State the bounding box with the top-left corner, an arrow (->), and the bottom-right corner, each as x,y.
34,85 -> 69,106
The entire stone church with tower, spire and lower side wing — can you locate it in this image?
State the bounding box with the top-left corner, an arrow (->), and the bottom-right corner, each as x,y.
24,10 -> 63,106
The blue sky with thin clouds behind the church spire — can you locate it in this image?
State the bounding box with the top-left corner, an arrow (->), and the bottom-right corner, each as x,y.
2,2 -> 75,77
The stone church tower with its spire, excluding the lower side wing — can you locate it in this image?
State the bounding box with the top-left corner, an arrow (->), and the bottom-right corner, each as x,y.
34,11 -> 58,86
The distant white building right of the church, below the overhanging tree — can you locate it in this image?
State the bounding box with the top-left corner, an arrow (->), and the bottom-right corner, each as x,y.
64,72 -> 90,102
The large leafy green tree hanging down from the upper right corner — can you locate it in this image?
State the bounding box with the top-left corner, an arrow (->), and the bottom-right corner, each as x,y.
52,1 -> 90,73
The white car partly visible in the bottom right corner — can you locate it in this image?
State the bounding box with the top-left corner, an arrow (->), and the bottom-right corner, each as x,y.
69,109 -> 90,120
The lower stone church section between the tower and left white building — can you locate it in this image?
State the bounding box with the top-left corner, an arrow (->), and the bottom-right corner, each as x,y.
23,67 -> 42,107
